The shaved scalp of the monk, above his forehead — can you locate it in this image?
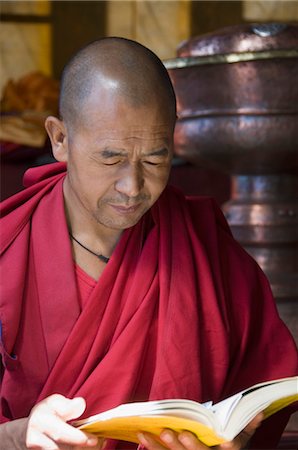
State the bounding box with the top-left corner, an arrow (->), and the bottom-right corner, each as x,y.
59,37 -> 176,126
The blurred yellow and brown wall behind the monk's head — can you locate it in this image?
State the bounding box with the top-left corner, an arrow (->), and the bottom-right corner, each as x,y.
0,0 -> 298,89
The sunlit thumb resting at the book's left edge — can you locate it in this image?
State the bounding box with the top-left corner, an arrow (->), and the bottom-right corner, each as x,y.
47,394 -> 86,421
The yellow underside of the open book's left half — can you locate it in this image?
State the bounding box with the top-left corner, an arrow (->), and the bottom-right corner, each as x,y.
79,416 -> 226,446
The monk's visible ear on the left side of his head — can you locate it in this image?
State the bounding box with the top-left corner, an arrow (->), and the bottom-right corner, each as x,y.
45,116 -> 68,162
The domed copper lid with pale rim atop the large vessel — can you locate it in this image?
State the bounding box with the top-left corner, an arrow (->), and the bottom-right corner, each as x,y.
165,23 -> 298,69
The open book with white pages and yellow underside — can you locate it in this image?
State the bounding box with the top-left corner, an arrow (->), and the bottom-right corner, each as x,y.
73,377 -> 298,446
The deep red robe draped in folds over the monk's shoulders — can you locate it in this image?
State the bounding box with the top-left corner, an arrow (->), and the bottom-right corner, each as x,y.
0,163 -> 297,446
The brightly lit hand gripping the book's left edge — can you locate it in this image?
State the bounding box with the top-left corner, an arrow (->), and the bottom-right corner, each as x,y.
26,394 -> 103,450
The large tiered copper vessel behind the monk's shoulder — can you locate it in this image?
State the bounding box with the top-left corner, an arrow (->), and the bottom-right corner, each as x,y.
165,24 -> 298,316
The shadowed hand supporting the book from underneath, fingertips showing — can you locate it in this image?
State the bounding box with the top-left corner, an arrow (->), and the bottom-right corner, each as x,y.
138,413 -> 263,450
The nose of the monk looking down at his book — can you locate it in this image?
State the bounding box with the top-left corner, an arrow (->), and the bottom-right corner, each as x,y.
115,163 -> 144,197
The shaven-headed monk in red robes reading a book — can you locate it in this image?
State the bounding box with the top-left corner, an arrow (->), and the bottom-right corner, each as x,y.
0,38 -> 297,450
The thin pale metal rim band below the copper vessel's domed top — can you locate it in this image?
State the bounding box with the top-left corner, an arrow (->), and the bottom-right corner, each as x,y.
163,48 -> 298,69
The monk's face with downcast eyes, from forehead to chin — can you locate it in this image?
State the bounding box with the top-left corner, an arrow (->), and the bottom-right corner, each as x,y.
65,92 -> 174,230
